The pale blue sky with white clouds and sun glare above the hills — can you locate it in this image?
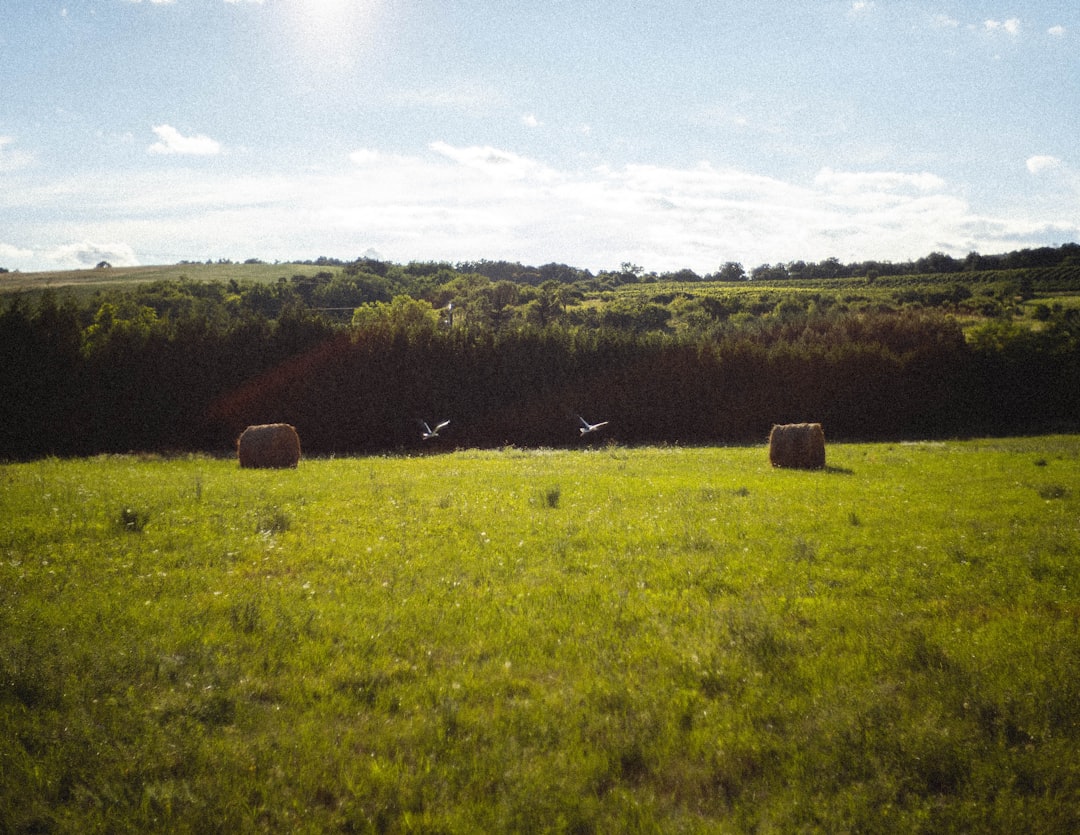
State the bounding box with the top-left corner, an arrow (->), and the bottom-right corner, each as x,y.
0,0 -> 1080,274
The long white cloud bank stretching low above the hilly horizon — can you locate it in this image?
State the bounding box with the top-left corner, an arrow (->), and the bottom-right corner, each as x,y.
0,142 -> 1080,273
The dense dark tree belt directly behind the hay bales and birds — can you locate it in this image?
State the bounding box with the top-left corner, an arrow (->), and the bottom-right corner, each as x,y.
0,261 -> 1080,458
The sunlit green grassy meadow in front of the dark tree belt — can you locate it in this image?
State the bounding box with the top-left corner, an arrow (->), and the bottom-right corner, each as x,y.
0,436 -> 1080,833
